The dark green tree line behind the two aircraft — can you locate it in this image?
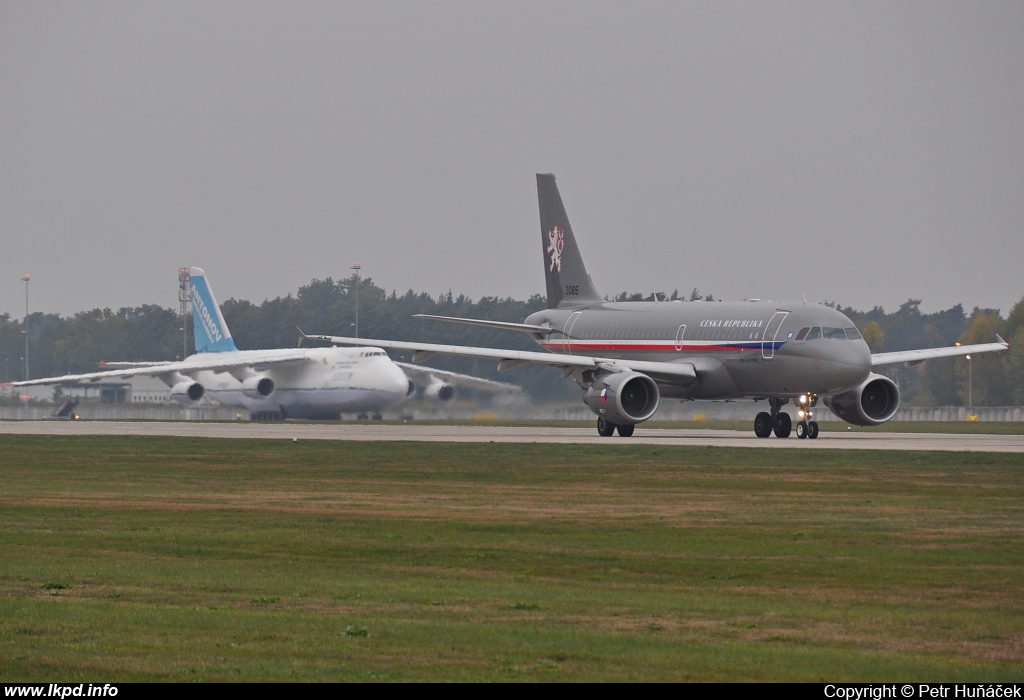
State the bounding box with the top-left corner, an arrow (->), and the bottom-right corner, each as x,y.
0,275 -> 1024,406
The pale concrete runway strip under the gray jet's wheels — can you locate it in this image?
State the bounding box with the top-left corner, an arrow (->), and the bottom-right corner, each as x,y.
0,421 -> 1024,452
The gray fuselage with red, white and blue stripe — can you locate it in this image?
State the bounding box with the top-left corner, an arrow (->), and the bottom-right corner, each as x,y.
526,301 -> 871,399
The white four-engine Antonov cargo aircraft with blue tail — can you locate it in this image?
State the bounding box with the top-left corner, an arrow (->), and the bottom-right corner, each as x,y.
8,267 -> 519,420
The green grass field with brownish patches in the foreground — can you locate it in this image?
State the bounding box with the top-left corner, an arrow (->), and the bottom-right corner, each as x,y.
0,436 -> 1024,682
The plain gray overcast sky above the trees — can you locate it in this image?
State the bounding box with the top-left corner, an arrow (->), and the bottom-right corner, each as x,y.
0,0 -> 1024,319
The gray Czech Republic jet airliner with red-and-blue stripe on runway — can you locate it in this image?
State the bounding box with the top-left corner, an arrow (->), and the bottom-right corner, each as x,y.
309,175 -> 1008,439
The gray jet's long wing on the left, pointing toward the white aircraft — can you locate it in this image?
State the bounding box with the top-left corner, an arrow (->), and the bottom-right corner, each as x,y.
303,334 -> 697,384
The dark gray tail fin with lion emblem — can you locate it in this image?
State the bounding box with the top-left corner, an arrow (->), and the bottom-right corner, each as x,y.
537,174 -> 603,309
